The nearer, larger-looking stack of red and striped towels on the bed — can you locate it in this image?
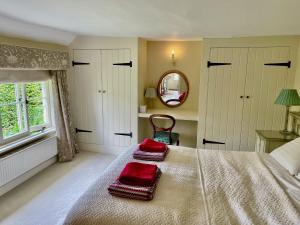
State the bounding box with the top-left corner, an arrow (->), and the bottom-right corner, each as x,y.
108,162 -> 161,200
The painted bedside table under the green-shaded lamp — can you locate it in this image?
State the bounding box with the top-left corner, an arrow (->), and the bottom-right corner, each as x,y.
255,130 -> 299,153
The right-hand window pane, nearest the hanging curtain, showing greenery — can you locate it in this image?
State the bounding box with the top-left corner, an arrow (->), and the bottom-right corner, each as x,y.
26,82 -> 47,127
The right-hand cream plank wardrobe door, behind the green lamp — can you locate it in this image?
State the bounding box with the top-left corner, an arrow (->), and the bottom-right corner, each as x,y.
240,47 -> 293,151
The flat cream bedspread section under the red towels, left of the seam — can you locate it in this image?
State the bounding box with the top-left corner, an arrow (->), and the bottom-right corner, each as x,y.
65,147 -> 207,225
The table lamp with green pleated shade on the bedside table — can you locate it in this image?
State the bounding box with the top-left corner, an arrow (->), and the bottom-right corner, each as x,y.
275,89 -> 300,134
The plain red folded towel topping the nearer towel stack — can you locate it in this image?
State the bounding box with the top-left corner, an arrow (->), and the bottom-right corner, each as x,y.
119,162 -> 157,186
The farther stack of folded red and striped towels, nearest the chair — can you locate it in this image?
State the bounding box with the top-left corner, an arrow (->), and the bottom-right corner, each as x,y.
133,138 -> 168,161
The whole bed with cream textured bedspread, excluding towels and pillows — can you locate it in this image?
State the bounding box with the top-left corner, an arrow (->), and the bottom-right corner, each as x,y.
64,146 -> 300,225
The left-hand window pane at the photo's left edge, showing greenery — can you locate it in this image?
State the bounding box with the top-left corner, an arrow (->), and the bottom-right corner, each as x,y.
0,84 -> 26,139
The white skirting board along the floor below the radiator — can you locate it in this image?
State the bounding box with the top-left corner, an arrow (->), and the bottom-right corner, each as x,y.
0,156 -> 57,196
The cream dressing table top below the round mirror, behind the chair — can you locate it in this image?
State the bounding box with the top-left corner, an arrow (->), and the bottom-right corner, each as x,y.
138,109 -> 198,122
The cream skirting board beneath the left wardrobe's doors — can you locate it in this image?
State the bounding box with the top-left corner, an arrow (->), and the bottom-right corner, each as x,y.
78,143 -> 129,155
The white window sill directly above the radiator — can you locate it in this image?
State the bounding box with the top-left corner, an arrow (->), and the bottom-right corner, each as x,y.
0,128 -> 56,155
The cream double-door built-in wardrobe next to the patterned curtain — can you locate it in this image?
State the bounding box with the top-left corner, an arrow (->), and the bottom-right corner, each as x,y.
70,39 -> 137,153
